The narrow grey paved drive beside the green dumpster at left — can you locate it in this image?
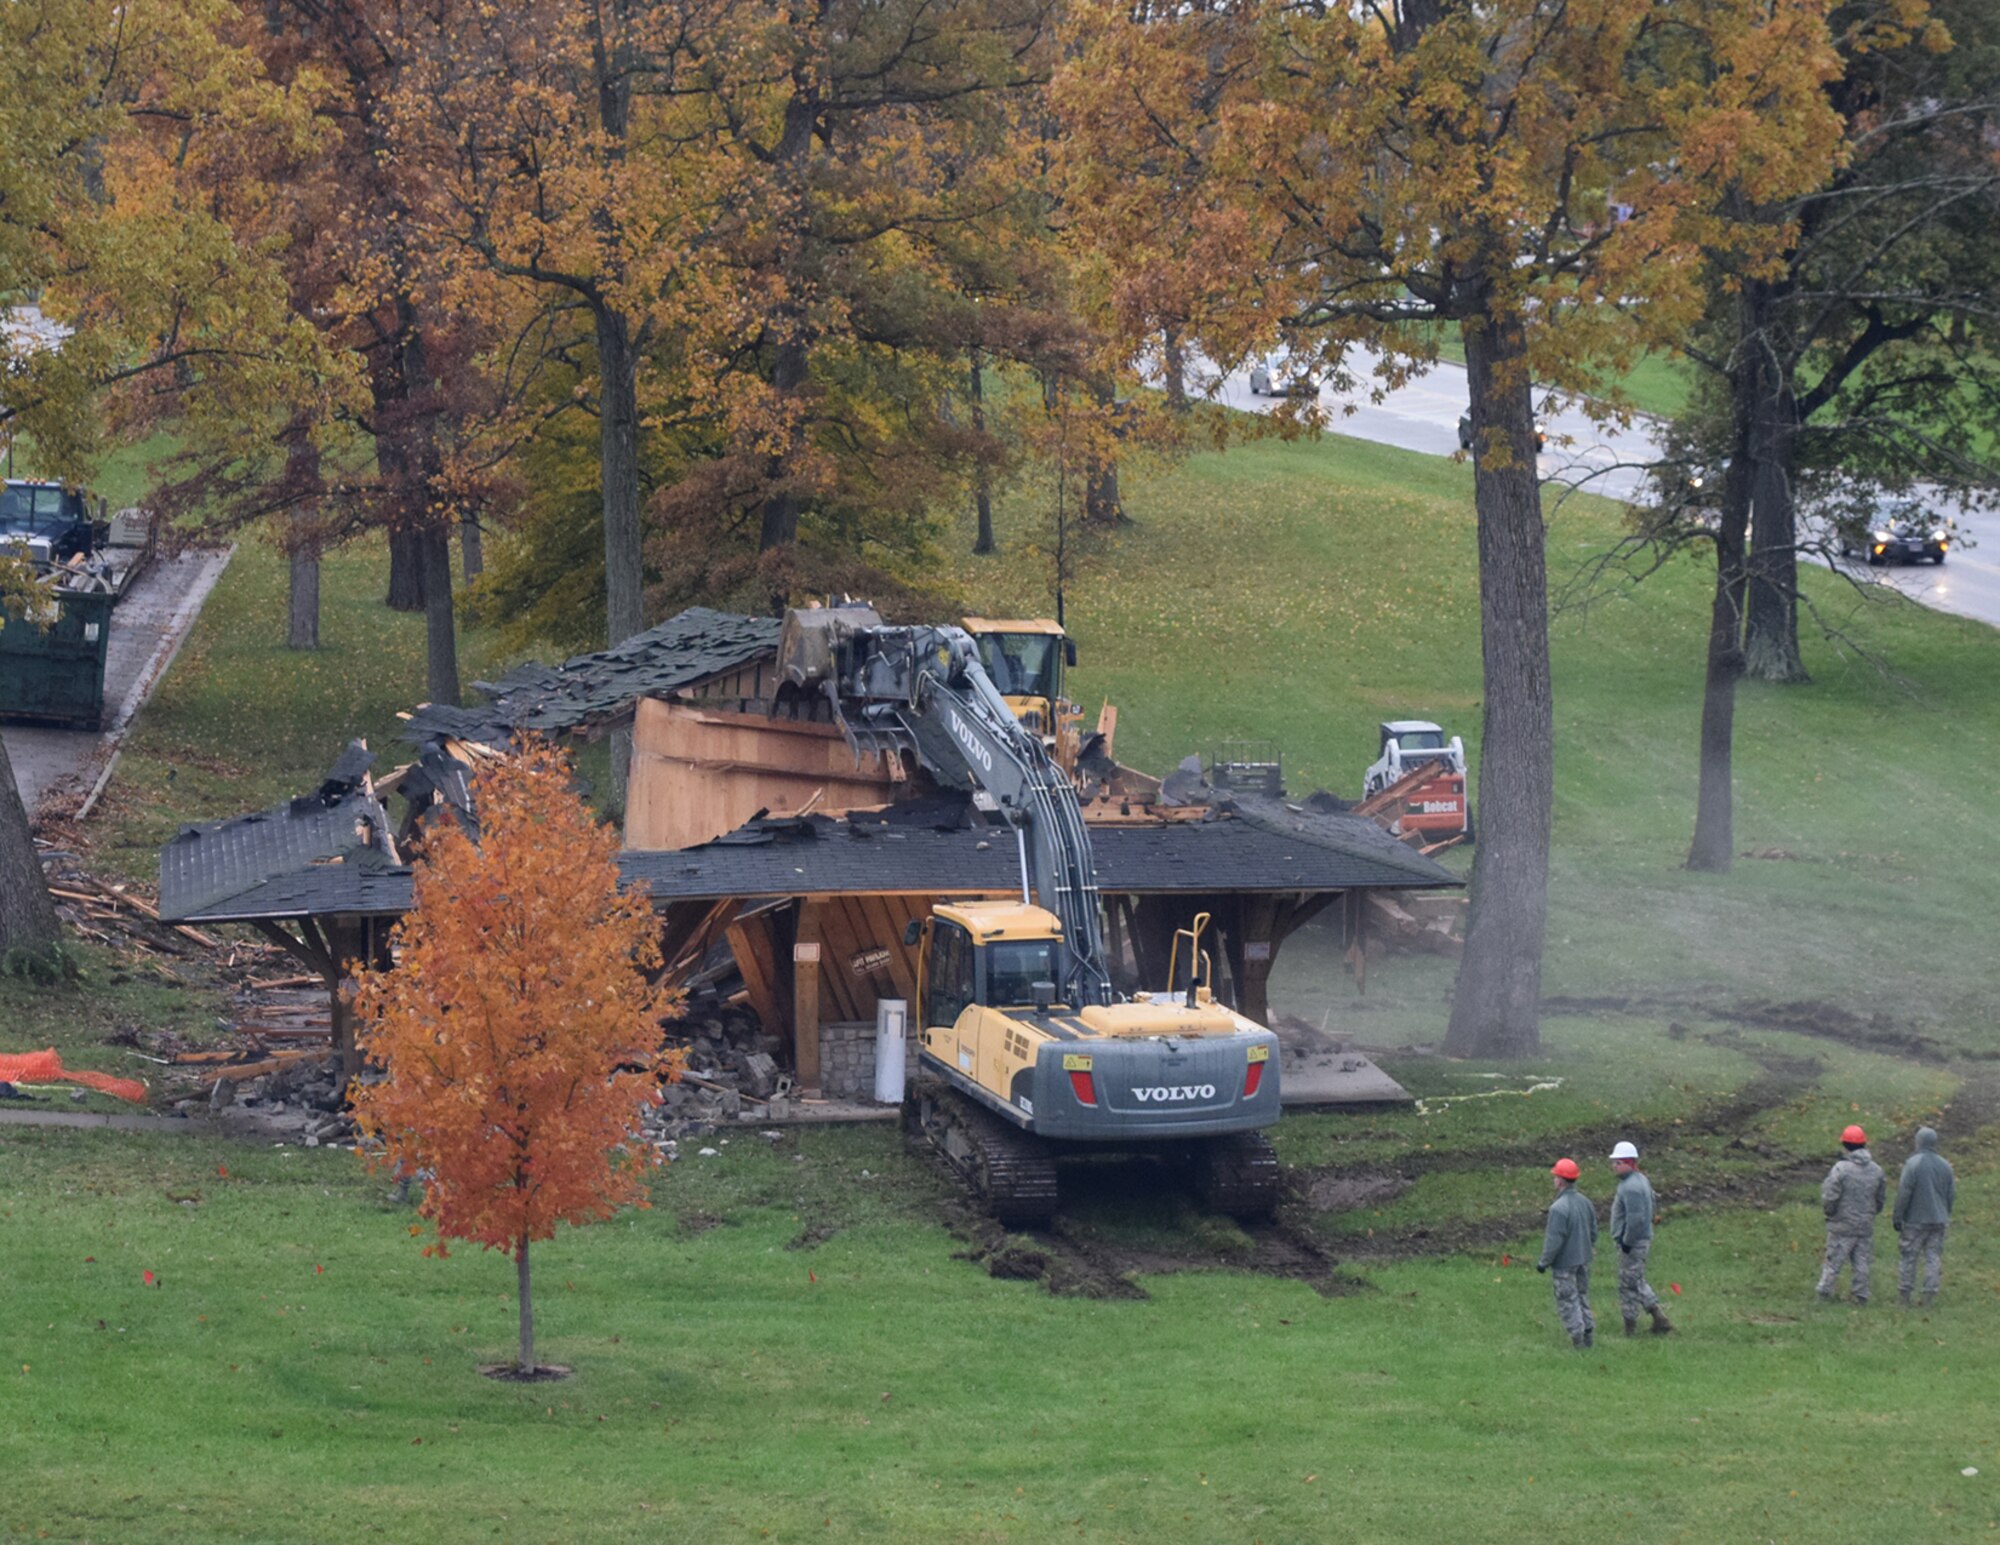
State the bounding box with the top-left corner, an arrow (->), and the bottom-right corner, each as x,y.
0,550 -> 230,811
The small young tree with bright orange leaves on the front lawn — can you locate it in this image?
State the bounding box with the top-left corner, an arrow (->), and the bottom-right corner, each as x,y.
354,742 -> 680,1373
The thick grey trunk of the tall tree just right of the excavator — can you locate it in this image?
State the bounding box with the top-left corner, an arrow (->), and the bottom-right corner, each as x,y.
1444,320 -> 1554,1057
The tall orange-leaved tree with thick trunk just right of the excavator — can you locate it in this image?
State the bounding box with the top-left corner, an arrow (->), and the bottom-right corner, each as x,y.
1054,0 -> 1840,1057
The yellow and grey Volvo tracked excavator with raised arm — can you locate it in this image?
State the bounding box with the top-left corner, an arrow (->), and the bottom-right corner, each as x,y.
778,606 -> 1278,1223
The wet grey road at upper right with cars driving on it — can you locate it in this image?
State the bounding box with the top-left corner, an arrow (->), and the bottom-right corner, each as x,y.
1216,354 -> 2000,626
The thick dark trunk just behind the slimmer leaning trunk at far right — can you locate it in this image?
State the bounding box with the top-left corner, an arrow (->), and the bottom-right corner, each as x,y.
1744,286 -> 1806,680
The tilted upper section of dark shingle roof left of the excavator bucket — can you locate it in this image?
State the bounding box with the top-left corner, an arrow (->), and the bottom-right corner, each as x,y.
404,606 -> 780,744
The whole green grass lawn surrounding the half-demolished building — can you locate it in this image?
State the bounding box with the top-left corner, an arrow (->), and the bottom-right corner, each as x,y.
11,416 -> 2000,1545
